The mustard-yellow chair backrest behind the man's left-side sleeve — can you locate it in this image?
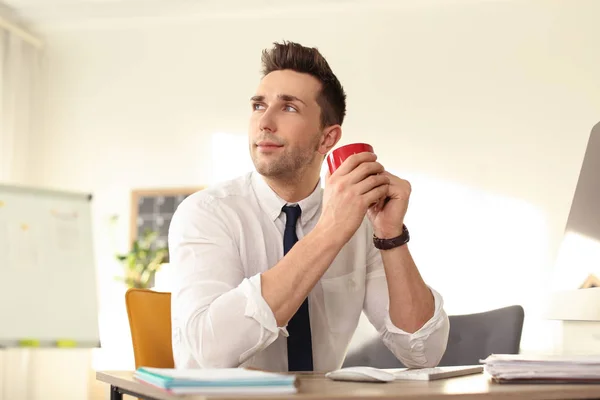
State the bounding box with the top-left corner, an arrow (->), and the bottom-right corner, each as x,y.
125,289 -> 175,368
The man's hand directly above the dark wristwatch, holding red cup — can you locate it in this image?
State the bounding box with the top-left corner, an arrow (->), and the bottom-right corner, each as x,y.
367,171 -> 411,239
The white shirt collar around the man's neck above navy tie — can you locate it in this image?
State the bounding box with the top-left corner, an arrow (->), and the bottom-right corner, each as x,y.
252,171 -> 323,224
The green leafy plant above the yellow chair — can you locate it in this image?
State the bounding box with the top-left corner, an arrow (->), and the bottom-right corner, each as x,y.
117,230 -> 168,289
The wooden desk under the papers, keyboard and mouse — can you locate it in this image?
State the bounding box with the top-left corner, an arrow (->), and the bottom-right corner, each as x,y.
96,372 -> 600,400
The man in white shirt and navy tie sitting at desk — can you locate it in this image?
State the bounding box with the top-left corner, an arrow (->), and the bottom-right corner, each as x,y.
169,42 -> 449,371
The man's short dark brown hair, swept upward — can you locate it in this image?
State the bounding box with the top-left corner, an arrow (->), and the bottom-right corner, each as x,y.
261,41 -> 346,127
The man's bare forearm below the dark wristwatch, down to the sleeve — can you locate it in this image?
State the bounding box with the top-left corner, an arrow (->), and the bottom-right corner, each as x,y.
381,245 -> 435,333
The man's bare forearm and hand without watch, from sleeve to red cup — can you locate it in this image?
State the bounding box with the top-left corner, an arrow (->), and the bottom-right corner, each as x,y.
261,153 -> 390,326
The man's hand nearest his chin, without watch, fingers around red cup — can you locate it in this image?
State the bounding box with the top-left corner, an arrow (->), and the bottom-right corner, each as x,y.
319,152 -> 392,243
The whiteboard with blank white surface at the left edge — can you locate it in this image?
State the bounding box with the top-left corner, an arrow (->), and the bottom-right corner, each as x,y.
0,185 -> 100,347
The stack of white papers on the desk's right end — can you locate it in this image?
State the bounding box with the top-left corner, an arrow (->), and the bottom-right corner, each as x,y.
482,354 -> 600,383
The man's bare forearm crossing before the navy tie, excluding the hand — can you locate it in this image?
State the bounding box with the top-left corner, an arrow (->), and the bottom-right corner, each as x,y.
261,226 -> 343,326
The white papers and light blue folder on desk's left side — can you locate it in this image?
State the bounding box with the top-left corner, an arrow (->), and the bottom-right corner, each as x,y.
134,367 -> 296,394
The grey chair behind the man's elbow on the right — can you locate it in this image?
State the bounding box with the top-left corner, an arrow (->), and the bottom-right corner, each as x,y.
343,305 -> 525,368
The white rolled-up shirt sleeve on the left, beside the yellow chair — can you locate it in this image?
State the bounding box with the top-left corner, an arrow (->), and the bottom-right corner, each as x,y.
169,196 -> 285,368
